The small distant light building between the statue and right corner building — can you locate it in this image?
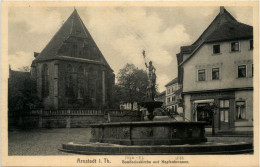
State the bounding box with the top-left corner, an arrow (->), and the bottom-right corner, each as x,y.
165,78 -> 183,113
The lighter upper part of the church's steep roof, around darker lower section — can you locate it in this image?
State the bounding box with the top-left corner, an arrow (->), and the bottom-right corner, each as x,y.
35,9 -> 112,70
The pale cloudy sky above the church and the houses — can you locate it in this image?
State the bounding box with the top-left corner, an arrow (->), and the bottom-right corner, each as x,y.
8,7 -> 253,91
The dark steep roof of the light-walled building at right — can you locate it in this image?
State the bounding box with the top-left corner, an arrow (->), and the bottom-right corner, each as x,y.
179,7 -> 253,65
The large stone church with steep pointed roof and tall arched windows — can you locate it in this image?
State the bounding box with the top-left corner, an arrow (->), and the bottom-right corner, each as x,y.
31,9 -> 115,109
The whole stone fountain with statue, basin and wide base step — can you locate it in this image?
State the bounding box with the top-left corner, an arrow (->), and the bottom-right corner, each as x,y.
60,52 -> 252,155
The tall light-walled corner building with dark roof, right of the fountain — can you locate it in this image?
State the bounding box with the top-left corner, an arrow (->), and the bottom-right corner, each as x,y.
177,7 -> 254,133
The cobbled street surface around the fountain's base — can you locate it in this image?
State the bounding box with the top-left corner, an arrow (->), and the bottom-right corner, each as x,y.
8,128 -> 253,155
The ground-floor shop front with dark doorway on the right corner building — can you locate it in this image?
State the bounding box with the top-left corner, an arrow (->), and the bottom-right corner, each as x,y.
190,92 -> 235,132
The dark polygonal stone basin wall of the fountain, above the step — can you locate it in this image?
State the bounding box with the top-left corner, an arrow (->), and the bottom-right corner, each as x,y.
90,121 -> 207,145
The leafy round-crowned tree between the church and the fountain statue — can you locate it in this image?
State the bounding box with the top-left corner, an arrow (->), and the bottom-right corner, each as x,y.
115,64 -> 148,110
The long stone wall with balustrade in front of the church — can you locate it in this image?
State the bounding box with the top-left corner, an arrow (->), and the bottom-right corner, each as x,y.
8,109 -> 142,128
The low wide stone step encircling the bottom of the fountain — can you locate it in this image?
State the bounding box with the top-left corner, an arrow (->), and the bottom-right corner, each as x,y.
59,142 -> 253,155
